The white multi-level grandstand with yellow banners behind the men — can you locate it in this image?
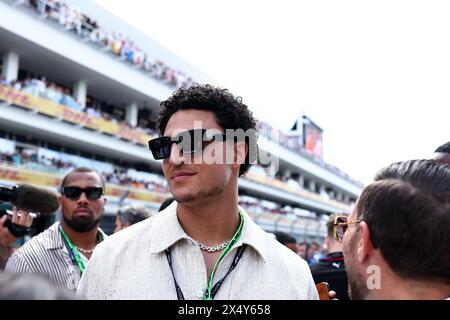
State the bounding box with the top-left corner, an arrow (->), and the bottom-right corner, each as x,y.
0,0 -> 363,241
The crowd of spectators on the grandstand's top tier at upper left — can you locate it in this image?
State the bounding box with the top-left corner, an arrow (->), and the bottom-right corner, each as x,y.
11,0 -> 193,87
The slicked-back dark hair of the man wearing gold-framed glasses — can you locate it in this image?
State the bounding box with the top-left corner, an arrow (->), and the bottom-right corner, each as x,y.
356,160 -> 450,283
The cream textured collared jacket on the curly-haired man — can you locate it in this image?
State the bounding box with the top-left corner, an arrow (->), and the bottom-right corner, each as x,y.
78,202 -> 318,300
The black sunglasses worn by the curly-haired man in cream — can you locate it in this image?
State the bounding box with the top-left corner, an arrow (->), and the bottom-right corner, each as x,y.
148,129 -> 226,160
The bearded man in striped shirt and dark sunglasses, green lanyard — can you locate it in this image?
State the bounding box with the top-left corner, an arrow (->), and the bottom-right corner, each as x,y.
6,167 -> 106,290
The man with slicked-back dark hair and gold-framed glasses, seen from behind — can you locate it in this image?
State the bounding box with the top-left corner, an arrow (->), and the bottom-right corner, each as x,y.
337,160 -> 450,300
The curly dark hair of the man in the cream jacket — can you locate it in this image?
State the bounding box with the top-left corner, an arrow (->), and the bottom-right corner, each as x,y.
156,84 -> 258,176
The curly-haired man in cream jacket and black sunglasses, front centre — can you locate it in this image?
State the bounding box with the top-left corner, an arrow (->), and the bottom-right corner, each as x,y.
78,85 -> 318,300
